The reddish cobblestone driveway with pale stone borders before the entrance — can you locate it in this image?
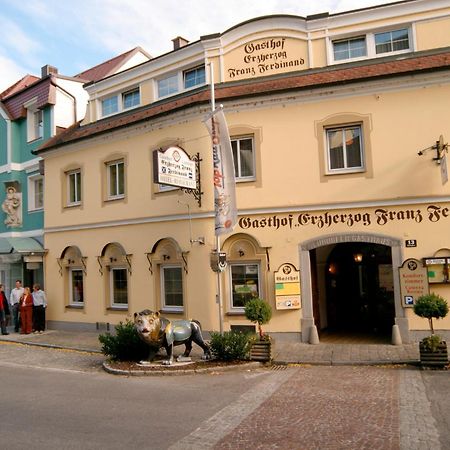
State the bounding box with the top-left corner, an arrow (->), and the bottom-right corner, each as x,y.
171,366 -> 450,450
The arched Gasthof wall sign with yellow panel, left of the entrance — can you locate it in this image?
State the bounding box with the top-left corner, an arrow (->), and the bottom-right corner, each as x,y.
275,263 -> 301,309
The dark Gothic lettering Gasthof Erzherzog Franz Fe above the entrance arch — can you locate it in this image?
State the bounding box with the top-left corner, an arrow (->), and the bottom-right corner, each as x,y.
238,204 -> 450,230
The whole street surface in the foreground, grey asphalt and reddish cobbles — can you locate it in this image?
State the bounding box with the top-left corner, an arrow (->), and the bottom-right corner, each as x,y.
0,342 -> 450,450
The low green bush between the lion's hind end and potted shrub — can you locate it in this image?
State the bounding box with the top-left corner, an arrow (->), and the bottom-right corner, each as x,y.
209,331 -> 251,361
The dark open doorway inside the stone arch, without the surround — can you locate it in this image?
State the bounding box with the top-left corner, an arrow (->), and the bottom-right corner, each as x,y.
311,242 -> 395,339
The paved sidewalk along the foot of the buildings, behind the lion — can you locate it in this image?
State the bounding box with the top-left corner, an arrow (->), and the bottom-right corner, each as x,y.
0,330 -> 426,365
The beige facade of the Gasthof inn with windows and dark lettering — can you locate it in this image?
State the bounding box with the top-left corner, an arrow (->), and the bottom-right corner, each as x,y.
40,0 -> 450,341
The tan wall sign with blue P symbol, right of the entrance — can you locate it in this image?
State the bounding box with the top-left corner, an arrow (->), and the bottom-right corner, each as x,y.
399,258 -> 429,308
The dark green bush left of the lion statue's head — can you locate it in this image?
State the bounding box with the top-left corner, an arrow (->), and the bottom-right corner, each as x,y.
98,319 -> 149,361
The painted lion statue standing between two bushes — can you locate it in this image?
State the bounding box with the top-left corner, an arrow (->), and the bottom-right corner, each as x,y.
134,309 -> 211,365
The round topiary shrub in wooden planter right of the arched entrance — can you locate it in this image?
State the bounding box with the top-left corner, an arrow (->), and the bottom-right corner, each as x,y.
414,294 -> 448,366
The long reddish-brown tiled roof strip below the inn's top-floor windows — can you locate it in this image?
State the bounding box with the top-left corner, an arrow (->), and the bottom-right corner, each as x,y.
33,48 -> 450,154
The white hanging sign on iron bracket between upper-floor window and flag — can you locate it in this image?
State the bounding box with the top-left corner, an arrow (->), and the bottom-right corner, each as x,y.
153,147 -> 197,189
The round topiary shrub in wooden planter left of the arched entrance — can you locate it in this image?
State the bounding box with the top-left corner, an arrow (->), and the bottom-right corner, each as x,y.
245,298 -> 272,361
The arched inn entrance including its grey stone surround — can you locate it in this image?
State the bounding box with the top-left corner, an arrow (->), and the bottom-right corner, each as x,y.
300,233 -> 409,342
